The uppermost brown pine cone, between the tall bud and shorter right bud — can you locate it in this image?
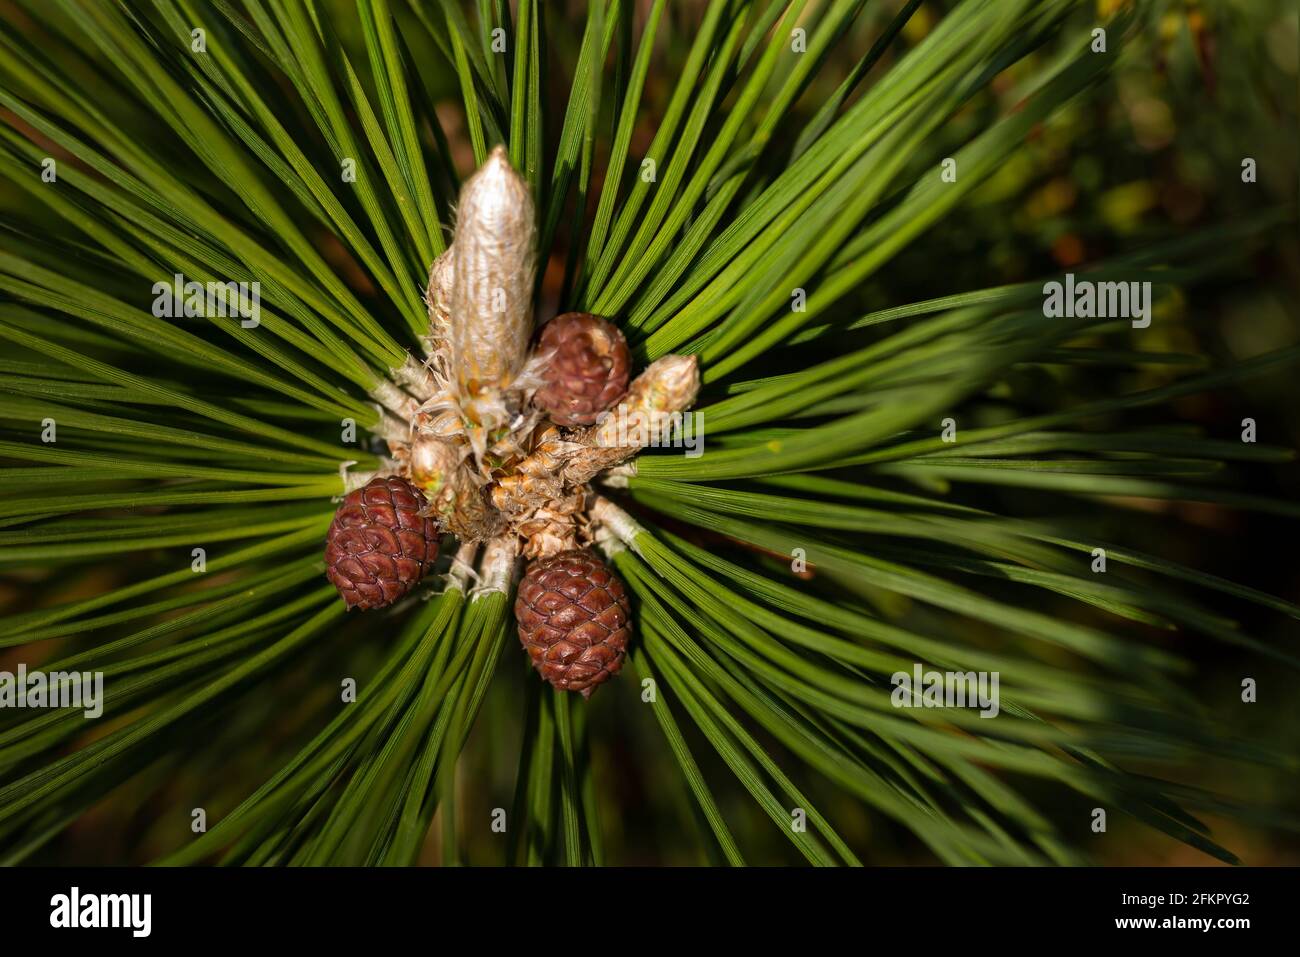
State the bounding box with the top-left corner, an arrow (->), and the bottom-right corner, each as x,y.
533,312 -> 632,426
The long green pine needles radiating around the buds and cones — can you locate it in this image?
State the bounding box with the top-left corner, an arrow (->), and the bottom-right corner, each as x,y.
0,0 -> 1300,865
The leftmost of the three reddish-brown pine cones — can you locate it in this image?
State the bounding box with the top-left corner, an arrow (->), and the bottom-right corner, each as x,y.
325,476 -> 438,611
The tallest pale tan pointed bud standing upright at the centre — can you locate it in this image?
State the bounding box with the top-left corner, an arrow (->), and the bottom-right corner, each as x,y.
450,147 -> 537,398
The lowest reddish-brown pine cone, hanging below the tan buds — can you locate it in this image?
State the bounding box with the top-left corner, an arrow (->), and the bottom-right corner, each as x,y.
515,549 -> 632,697
